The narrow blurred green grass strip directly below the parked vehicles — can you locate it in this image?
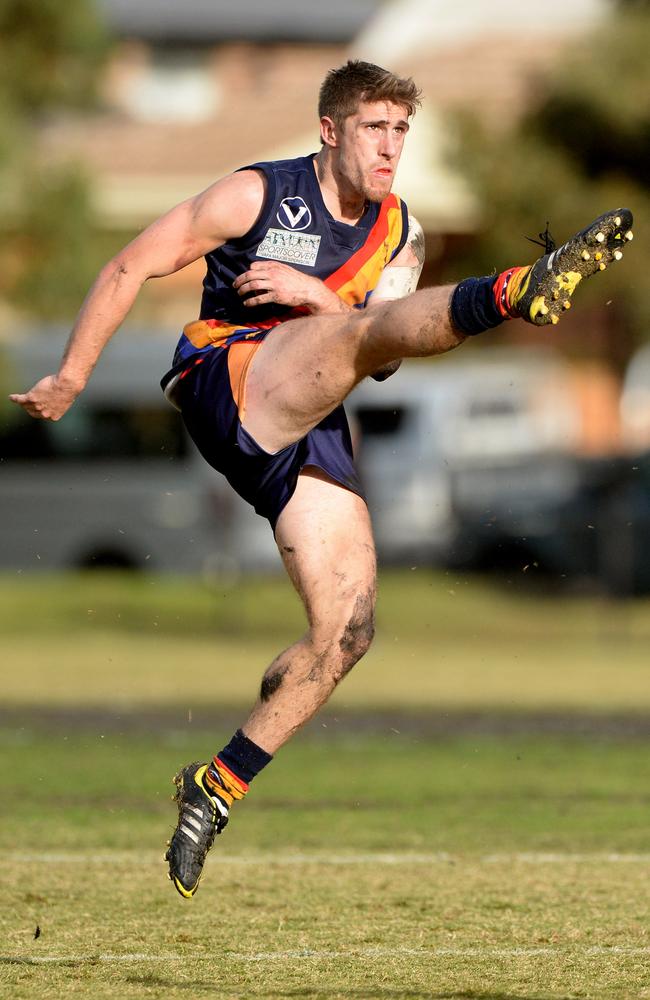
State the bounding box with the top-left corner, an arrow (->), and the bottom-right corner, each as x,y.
5,569 -> 650,643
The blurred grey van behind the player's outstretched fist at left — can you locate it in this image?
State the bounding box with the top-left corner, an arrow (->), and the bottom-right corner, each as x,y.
0,329 -> 279,574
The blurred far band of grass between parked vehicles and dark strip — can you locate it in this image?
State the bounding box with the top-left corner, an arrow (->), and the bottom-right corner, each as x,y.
0,571 -> 650,713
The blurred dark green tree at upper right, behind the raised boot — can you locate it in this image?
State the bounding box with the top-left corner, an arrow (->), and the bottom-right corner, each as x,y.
451,2 -> 650,348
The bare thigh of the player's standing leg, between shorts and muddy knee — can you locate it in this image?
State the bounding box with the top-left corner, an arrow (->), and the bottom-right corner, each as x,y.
275,466 -> 376,637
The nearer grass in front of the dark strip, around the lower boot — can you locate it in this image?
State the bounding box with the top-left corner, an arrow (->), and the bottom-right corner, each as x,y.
0,730 -> 650,1000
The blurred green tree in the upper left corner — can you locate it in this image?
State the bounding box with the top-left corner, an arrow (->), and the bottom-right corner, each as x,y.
0,0 -> 107,319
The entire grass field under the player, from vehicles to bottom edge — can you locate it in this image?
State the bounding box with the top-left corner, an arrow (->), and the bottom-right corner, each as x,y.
0,573 -> 650,1000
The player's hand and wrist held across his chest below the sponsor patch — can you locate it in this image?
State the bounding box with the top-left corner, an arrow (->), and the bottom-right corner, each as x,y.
233,260 -> 348,313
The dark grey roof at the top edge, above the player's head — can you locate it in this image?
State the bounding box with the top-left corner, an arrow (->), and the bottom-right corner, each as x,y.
95,0 -> 379,45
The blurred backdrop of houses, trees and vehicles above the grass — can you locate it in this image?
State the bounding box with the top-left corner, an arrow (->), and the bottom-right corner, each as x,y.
0,0 -> 650,595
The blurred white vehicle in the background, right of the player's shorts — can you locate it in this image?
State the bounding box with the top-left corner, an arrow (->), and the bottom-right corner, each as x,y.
346,347 -> 580,562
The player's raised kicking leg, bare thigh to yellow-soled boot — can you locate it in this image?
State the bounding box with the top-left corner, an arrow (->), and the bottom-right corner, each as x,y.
244,209 -> 632,452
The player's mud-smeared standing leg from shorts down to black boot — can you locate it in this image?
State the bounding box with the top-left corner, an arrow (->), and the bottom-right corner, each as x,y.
166,467 -> 376,898
